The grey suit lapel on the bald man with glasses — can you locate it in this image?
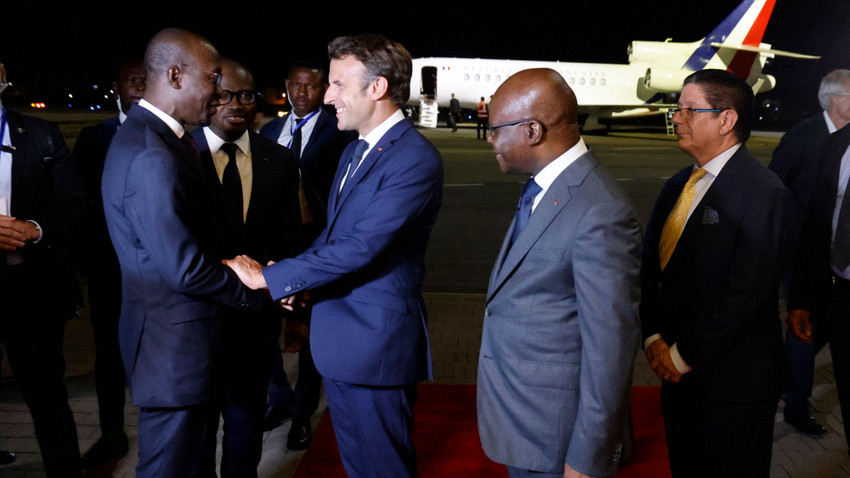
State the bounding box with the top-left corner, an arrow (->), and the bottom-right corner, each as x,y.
487,152 -> 597,301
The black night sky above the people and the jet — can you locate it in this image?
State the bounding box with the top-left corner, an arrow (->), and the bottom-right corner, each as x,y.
0,0 -> 850,116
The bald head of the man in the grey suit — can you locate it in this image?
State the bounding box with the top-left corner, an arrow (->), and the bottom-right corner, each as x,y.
489,68 -> 581,174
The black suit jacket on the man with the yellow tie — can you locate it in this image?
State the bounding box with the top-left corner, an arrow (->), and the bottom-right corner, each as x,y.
640,146 -> 797,402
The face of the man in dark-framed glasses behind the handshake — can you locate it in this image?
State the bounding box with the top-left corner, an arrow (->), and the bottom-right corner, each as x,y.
210,61 -> 257,142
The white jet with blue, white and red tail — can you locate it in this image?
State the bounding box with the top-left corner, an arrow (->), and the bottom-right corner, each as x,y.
408,0 -> 819,131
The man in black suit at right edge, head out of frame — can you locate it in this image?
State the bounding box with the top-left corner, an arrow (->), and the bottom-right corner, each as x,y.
788,114 -> 850,458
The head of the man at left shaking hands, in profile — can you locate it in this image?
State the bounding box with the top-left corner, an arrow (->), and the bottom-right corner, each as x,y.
139,28 -> 221,125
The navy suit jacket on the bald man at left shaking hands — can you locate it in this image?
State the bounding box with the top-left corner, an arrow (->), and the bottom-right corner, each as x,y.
101,107 -> 263,407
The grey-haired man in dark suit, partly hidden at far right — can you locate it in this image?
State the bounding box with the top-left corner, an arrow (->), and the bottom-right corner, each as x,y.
768,70 -> 850,437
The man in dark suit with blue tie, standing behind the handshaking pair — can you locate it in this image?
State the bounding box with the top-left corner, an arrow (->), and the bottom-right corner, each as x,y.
260,63 -> 357,450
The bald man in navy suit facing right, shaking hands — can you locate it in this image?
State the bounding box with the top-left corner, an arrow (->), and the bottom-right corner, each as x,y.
101,29 -> 263,478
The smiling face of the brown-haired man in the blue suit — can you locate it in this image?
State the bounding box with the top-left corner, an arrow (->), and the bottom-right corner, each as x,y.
325,56 -> 383,136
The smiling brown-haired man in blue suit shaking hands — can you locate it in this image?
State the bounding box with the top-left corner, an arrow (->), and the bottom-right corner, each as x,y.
226,35 -> 443,477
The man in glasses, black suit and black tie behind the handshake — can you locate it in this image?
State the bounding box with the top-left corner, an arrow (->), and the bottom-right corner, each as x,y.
192,59 -> 301,477
